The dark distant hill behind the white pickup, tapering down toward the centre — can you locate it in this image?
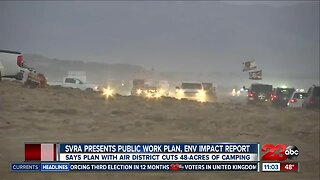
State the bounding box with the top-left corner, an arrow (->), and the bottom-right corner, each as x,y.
24,54 -> 151,83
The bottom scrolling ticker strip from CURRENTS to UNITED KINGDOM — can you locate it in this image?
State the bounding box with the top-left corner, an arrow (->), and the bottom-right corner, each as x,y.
10,162 -> 260,172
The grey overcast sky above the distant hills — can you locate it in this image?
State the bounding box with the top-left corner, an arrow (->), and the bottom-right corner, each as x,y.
0,1 -> 319,77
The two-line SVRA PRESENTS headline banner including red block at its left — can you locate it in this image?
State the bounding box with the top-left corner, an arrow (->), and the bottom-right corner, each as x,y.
25,143 -> 260,162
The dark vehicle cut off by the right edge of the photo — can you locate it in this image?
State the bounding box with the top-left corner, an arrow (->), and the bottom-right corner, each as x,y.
302,85 -> 320,109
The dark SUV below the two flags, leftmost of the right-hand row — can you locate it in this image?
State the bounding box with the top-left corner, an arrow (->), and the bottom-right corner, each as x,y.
248,84 -> 272,103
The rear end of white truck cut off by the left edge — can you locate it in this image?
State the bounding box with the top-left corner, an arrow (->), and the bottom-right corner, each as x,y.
0,50 -> 23,81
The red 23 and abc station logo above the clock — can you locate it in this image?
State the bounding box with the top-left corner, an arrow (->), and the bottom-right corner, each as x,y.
261,144 -> 299,161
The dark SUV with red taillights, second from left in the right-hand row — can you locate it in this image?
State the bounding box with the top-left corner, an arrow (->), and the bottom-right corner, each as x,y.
271,87 -> 295,107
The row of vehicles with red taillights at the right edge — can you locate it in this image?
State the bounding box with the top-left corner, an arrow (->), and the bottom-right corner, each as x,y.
248,83 -> 320,109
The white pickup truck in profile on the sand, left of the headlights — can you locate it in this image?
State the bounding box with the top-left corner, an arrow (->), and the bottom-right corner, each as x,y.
48,77 -> 100,91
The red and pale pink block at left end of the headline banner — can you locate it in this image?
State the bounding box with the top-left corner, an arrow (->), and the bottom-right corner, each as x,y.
24,144 -> 56,161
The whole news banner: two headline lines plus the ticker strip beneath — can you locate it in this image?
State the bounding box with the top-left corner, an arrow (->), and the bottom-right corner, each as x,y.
10,143 -> 260,172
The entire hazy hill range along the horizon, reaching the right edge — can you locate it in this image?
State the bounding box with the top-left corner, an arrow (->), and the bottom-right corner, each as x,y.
24,54 -> 319,89
